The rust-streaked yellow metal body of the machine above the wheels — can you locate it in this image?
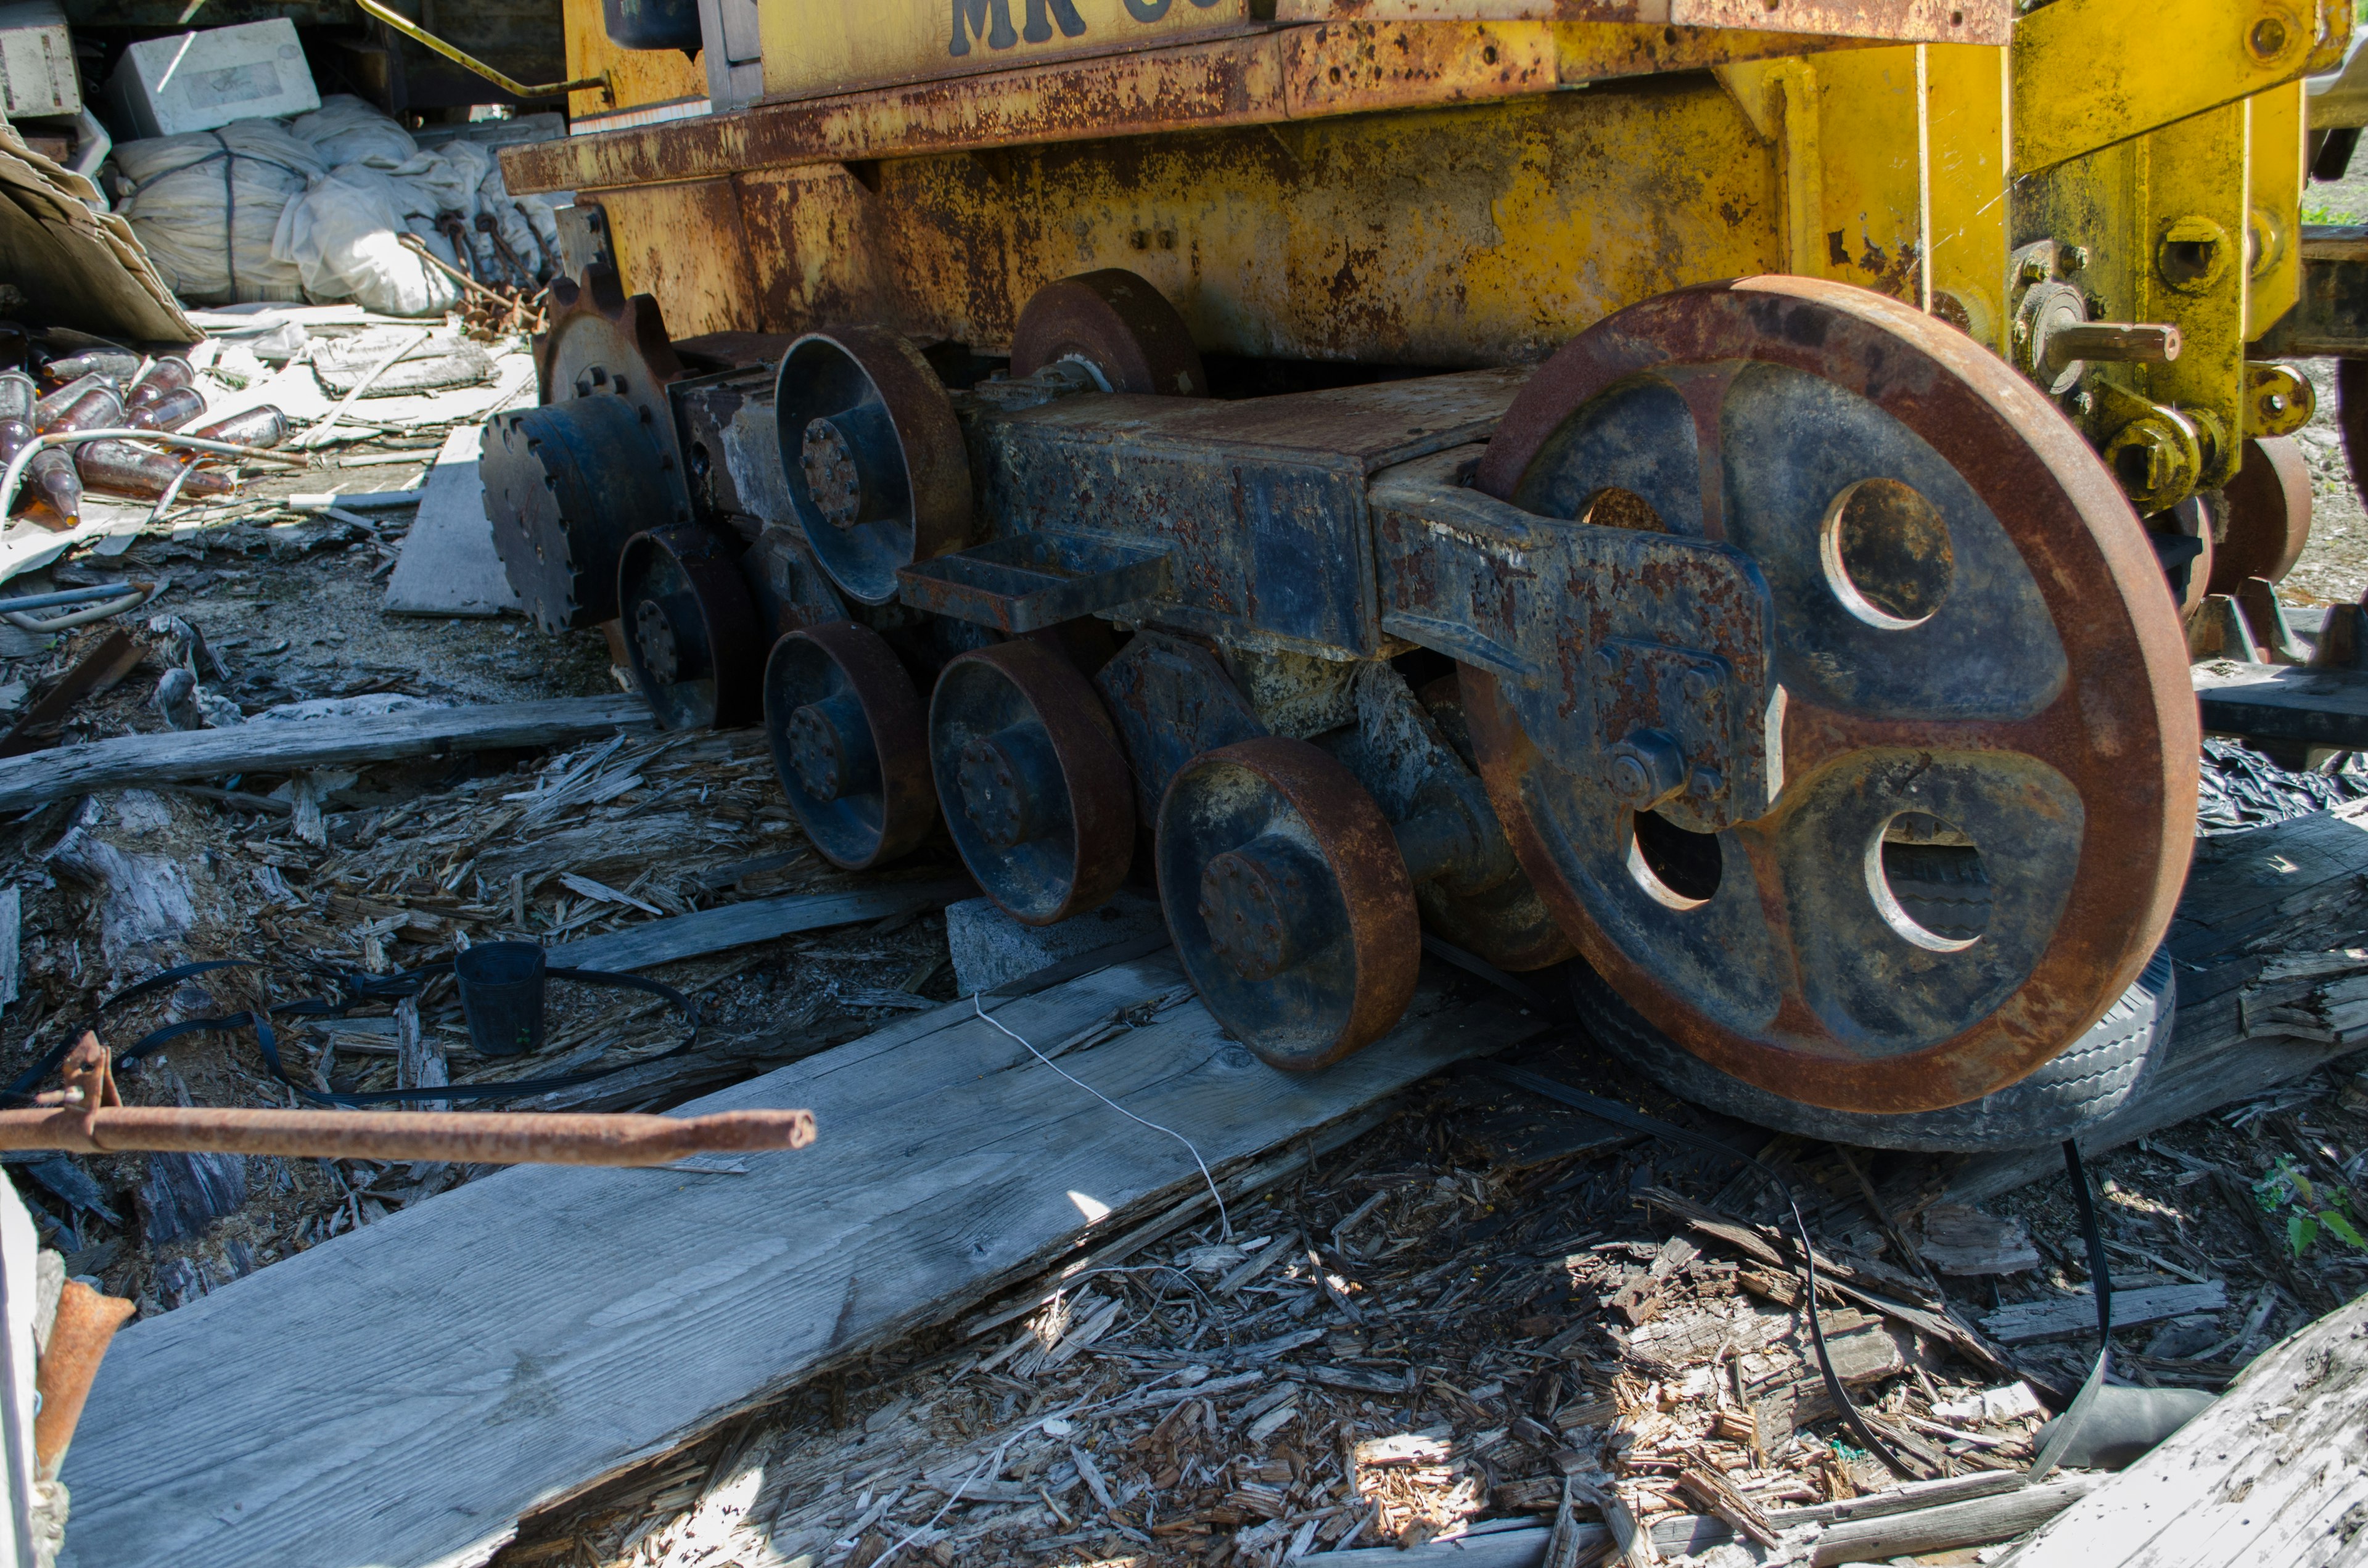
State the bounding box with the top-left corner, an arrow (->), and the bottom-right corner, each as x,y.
504,0 -> 2351,509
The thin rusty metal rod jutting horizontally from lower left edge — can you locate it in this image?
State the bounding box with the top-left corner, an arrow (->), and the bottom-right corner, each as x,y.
0,1104 -> 815,1165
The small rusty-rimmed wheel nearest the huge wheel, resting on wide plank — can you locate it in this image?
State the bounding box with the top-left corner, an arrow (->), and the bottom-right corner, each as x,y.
1156,737 -> 1423,1070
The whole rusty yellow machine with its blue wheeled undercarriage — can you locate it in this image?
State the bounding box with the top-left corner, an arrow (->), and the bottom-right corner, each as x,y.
485,0 -> 2368,1144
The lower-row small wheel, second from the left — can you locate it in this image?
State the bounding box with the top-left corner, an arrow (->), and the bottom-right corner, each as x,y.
765,620 -> 938,872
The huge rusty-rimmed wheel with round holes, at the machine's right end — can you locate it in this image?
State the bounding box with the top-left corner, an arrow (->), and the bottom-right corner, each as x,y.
1463,277 -> 2200,1113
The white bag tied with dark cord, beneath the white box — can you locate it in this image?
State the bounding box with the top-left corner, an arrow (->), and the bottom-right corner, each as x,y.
113,121 -> 329,306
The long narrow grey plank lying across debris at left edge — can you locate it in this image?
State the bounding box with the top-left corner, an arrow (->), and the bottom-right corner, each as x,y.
0,692 -> 651,810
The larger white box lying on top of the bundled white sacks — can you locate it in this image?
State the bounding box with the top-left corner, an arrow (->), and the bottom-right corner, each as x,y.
107,17 -> 319,140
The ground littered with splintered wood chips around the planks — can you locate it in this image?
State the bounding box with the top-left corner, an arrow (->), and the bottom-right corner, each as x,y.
14,317 -> 2368,1568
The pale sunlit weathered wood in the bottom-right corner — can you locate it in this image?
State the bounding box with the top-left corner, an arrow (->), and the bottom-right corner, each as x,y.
2015,1295 -> 2368,1568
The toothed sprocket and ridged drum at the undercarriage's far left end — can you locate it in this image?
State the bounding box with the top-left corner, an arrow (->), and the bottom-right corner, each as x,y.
481,268 -> 689,630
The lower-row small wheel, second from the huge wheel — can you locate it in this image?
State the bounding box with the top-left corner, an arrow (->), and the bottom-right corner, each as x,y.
928,639 -> 1134,926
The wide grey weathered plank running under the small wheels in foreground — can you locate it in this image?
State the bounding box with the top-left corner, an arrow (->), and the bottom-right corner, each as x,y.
64,957 -> 1534,1568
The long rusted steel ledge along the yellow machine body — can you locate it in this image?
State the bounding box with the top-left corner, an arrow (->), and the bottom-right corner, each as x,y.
502,21 -> 1885,196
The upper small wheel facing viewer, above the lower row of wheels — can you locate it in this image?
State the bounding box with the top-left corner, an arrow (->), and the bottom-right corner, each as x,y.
775,327 -> 971,604
